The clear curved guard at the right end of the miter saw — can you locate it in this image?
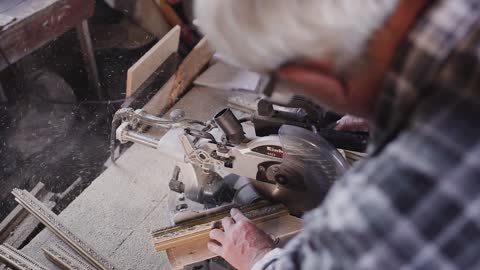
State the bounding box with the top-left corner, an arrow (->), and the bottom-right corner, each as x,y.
278,125 -> 349,207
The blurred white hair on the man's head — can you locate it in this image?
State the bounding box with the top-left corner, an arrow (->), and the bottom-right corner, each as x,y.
195,0 -> 399,72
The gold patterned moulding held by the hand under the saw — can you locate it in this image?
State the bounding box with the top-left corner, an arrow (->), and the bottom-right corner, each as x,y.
153,202 -> 289,251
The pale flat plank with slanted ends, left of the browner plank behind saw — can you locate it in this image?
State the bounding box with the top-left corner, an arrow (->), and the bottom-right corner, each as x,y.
127,26 -> 180,98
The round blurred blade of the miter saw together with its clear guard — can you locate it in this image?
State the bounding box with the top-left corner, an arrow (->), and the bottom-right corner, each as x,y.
254,126 -> 349,214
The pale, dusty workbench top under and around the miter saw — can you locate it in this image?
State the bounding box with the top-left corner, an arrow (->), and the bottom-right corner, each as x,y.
23,87 -> 245,270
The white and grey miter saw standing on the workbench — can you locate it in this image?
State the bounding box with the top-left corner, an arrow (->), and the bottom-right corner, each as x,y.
112,105 -> 348,223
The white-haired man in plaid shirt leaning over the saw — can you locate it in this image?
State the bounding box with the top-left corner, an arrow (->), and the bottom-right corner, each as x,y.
196,0 -> 480,269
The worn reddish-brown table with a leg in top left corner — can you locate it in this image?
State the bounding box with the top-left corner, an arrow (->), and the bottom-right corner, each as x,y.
0,0 -> 103,97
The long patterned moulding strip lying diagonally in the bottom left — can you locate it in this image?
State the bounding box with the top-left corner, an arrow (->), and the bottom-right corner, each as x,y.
12,189 -> 115,270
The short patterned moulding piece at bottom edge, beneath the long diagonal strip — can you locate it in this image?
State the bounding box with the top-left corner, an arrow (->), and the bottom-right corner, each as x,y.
42,245 -> 95,270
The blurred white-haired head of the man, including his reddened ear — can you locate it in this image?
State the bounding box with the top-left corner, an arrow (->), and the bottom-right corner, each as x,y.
195,0 -> 400,117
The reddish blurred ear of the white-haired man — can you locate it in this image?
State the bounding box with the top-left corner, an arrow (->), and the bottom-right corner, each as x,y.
277,61 -> 348,111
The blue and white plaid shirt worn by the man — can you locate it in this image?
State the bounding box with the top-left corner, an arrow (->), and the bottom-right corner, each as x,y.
254,0 -> 480,269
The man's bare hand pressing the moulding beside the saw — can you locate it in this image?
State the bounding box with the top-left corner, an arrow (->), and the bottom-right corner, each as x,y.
208,209 -> 275,270
